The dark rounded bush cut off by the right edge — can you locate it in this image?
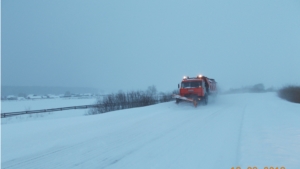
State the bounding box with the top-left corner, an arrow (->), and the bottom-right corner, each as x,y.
278,86 -> 300,103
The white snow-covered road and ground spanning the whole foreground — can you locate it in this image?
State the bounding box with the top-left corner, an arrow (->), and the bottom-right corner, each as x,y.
1,93 -> 300,169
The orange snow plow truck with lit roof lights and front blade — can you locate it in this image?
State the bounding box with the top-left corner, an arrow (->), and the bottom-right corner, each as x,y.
173,75 -> 217,107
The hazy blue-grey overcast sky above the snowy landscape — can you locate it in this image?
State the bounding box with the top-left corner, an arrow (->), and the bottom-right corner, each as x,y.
1,0 -> 300,91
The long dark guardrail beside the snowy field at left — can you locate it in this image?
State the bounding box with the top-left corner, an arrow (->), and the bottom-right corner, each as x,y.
1,104 -> 99,118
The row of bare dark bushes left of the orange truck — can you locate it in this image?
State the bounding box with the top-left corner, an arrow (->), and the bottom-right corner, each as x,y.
88,86 -> 178,115
